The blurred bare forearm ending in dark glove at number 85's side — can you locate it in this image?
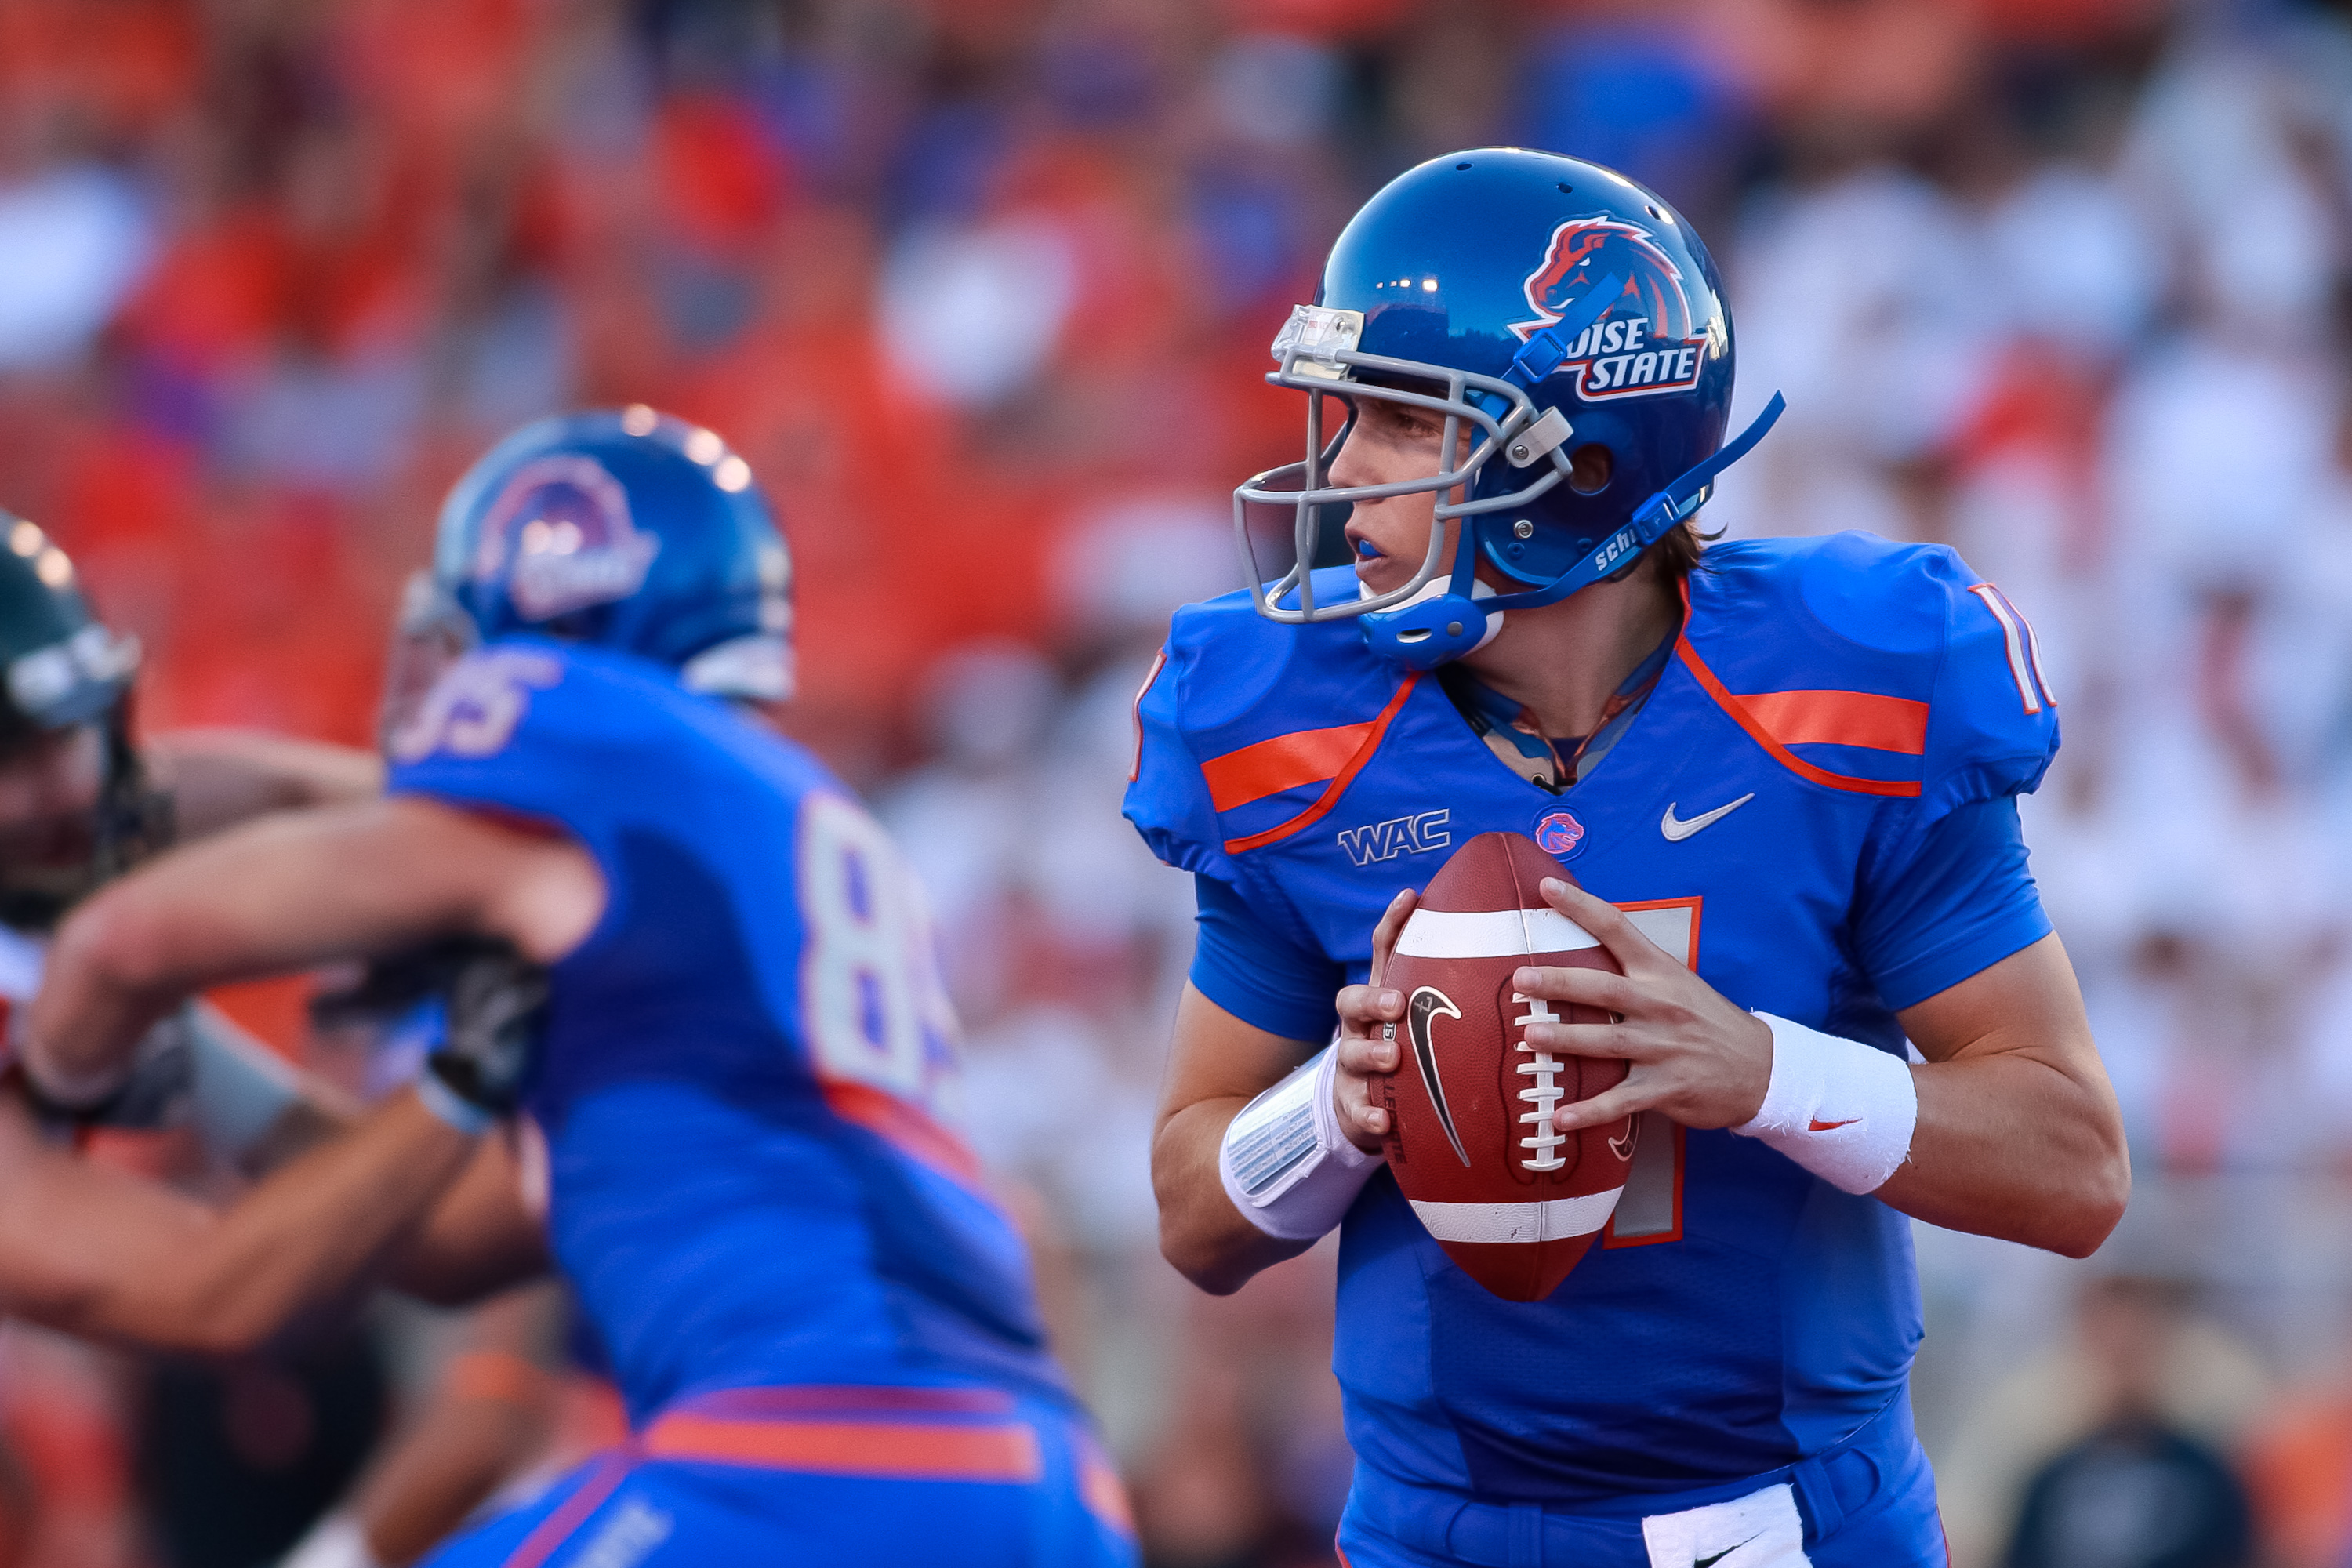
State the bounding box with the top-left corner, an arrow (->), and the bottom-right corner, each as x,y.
65,1093 -> 475,1354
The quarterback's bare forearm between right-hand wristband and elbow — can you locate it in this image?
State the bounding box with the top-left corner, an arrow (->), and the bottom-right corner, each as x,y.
1877,1051 -> 2131,1258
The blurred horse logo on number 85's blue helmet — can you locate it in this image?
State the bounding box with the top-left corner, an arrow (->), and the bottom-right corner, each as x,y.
473,456 -> 661,621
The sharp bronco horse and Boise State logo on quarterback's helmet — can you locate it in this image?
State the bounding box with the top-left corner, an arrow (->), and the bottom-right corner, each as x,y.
1510,219 -> 1710,402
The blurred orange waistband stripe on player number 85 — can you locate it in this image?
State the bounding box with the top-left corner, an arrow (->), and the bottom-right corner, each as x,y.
637,1413 -> 1044,1483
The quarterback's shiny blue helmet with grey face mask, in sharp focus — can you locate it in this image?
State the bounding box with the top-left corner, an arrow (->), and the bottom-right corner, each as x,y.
1235,148 -> 1783,670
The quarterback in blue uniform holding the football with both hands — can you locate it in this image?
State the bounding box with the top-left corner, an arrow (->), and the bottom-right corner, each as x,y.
1127,148 -> 2129,1568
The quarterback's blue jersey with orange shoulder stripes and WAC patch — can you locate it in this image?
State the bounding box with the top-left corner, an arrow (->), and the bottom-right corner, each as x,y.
1127,534 -> 2058,1507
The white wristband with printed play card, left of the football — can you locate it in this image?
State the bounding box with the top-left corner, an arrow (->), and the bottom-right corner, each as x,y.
1216,1046 -> 1388,1241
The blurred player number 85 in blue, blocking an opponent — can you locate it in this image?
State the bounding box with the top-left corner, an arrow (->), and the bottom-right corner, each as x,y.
28,407 -> 1131,1563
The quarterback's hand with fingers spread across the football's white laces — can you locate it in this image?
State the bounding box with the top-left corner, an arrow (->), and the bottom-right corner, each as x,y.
1512,877 -> 1771,1133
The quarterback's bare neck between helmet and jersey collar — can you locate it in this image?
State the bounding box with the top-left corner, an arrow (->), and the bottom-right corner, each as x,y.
1463,560 -> 1682,736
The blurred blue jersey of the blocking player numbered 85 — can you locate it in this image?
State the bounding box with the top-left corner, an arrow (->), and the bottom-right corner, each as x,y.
390,640 -> 1061,1417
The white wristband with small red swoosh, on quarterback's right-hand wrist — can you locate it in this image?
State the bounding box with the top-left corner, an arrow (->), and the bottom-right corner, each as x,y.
1731,1013 -> 1919,1194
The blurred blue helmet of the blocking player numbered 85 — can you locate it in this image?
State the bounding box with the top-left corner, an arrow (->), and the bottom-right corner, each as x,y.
421,405 -> 793,701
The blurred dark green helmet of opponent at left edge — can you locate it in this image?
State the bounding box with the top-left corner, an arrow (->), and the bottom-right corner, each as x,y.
0,513 -> 172,928
